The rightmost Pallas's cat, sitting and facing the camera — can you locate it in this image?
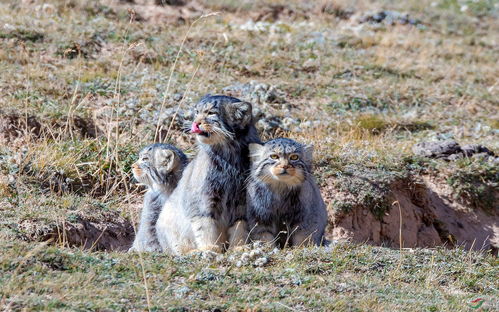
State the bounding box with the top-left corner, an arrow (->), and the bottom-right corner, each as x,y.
247,138 -> 327,247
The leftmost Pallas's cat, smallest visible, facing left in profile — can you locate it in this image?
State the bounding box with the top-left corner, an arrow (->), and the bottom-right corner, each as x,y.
129,144 -> 187,251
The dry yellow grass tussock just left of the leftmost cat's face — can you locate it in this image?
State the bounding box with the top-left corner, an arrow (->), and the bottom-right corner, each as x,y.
19,139 -> 139,196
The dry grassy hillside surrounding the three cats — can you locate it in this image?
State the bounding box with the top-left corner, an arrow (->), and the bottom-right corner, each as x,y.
0,0 -> 499,311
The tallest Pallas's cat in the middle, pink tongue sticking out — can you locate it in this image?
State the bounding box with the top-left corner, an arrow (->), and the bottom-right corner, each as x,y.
156,95 -> 260,254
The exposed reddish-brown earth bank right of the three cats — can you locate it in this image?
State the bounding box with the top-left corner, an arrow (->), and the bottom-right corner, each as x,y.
328,176 -> 499,254
